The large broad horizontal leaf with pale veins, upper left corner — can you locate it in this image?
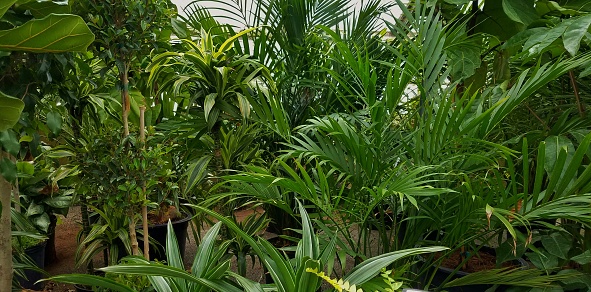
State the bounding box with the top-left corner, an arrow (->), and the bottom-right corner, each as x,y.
0,14 -> 94,53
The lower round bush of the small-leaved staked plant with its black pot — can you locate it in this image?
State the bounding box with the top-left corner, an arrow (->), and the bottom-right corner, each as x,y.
80,126 -> 190,264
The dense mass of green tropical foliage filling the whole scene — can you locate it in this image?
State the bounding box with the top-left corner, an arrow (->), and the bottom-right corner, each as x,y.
0,0 -> 591,291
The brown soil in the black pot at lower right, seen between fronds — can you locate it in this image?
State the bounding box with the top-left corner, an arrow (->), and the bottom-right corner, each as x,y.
431,247 -> 527,292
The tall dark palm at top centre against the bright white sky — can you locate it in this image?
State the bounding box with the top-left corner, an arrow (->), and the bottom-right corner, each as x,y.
183,0 -> 386,128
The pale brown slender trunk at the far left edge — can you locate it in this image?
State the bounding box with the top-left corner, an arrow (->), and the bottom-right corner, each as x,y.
0,148 -> 12,291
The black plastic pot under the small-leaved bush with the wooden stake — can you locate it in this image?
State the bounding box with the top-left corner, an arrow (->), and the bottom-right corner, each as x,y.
117,214 -> 192,260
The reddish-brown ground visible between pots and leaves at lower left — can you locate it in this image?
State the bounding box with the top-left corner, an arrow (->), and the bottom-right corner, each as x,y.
33,207 -> 263,292
